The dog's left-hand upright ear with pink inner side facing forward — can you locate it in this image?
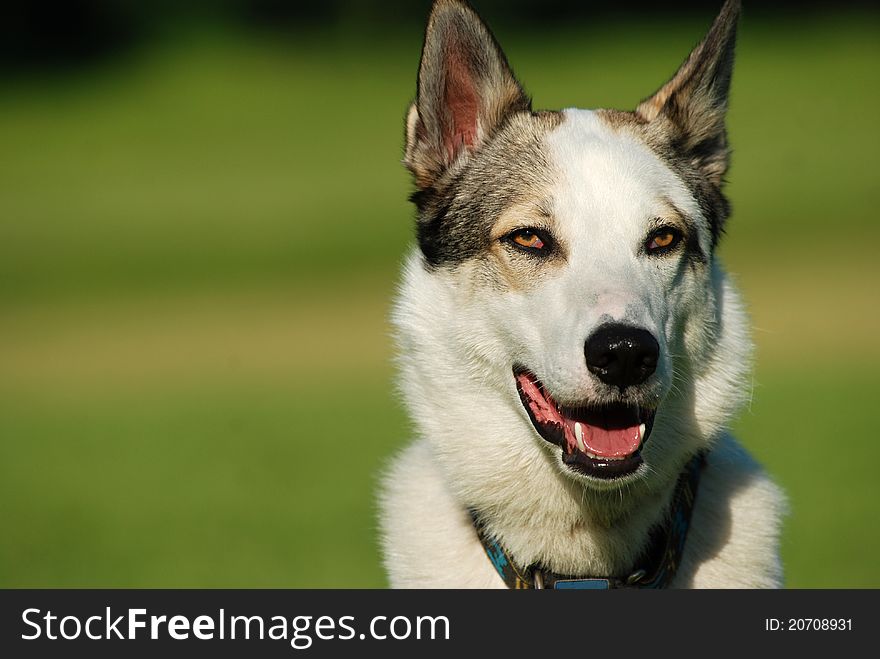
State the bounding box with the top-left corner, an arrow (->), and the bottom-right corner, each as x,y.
404,0 -> 530,189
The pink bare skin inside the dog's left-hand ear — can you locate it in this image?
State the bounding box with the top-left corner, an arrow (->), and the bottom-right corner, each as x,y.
443,45 -> 480,163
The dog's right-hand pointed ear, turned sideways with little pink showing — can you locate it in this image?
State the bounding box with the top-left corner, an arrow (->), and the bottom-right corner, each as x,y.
636,0 -> 740,185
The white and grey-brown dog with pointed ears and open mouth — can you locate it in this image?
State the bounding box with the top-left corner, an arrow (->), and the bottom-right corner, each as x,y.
380,0 -> 786,589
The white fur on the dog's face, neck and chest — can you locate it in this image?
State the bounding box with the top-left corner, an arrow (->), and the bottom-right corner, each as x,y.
381,110 -> 785,587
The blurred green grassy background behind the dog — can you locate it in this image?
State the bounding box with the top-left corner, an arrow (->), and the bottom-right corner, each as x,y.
0,2 -> 880,587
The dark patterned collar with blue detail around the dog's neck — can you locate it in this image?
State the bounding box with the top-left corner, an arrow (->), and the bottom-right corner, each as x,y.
469,453 -> 706,590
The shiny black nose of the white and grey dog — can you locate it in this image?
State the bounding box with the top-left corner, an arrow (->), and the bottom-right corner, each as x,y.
584,323 -> 660,389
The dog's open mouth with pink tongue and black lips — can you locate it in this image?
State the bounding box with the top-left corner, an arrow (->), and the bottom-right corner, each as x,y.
514,368 -> 656,479
